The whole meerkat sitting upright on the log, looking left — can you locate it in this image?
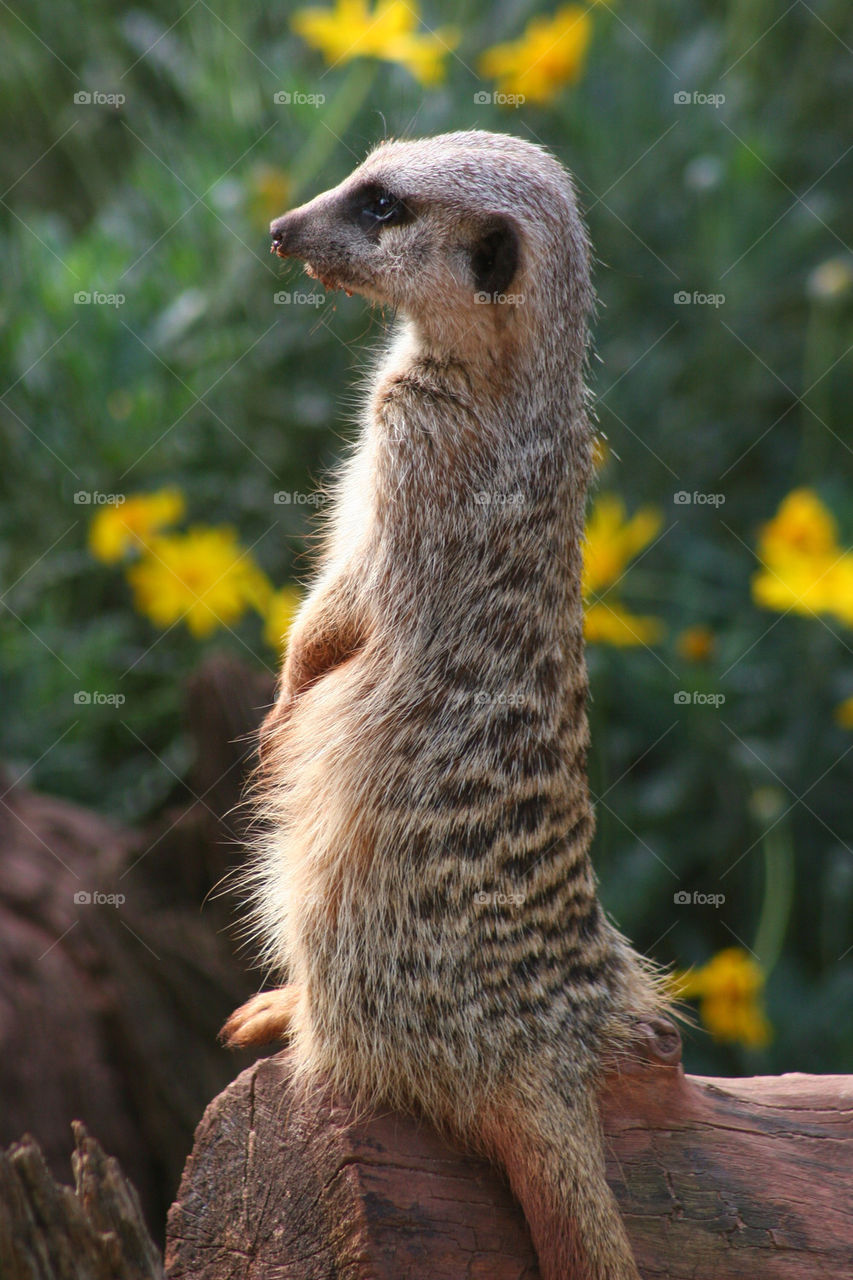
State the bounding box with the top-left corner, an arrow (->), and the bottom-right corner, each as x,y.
223,131 -> 667,1280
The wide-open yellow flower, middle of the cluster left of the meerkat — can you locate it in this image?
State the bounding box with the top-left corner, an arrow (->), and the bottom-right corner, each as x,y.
127,525 -> 272,636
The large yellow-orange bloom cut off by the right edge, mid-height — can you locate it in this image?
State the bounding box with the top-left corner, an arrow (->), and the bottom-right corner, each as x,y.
752,489 -> 853,626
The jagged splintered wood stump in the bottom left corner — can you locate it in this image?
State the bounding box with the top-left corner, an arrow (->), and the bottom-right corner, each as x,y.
0,1124 -> 163,1280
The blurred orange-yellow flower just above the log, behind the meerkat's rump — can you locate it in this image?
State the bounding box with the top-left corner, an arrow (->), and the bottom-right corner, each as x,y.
672,947 -> 772,1048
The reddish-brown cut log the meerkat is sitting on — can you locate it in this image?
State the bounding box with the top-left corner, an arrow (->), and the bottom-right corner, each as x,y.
165,1034 -> 853,1280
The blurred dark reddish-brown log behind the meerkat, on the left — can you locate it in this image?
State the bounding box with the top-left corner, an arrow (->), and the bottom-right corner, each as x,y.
0,655 -> 273,1233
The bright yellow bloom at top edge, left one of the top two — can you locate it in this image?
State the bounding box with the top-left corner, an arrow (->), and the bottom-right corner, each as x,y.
291,0 -> 460,84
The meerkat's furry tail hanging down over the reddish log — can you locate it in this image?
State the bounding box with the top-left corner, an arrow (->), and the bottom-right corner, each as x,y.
487,1093 -> 640,1280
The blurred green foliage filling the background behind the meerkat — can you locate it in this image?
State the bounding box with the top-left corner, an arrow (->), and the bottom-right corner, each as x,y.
0,0 -> 853,1073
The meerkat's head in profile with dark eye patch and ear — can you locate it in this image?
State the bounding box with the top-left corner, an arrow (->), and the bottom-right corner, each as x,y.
270,131 -> 589,366
